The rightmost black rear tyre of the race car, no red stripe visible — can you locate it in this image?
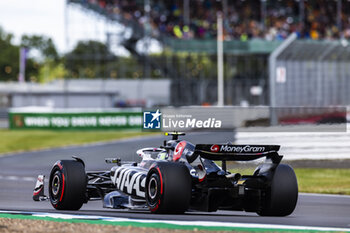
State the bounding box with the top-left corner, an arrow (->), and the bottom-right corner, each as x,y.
257,164 -> 298,216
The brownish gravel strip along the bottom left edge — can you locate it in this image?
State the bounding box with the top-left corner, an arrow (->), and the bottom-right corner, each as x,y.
0,218 -> 242,233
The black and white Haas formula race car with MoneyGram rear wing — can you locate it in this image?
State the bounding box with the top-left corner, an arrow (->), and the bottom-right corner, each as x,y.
33,133 -> 298,216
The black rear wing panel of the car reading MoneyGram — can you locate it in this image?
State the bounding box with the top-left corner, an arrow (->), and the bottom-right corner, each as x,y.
194,144 -> 282,163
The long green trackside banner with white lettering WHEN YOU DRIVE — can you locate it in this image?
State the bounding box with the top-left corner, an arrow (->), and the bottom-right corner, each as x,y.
9,112 -> 142,129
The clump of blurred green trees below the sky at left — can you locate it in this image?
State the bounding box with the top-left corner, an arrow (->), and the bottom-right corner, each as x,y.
0,28 -> 116,82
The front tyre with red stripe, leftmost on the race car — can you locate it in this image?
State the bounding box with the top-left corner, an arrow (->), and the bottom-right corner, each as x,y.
49,160 -> 86,210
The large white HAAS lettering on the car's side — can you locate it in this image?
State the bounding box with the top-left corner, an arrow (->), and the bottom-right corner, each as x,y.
112,167 -> 146,197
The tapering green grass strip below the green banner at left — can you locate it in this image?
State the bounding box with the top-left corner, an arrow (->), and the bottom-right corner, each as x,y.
0,129 -> 155,154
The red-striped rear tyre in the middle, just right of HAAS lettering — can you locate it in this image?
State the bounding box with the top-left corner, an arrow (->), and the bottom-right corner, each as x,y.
145,162 -> 191,214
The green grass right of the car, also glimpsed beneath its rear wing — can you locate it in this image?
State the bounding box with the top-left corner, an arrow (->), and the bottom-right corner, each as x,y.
231,168 -> 350,195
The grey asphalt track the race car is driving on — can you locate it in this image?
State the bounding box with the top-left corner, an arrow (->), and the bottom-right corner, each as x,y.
0,132 -> 350,228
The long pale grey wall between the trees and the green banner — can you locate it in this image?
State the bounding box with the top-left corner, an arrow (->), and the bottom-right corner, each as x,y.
0,79 -> 170,108
